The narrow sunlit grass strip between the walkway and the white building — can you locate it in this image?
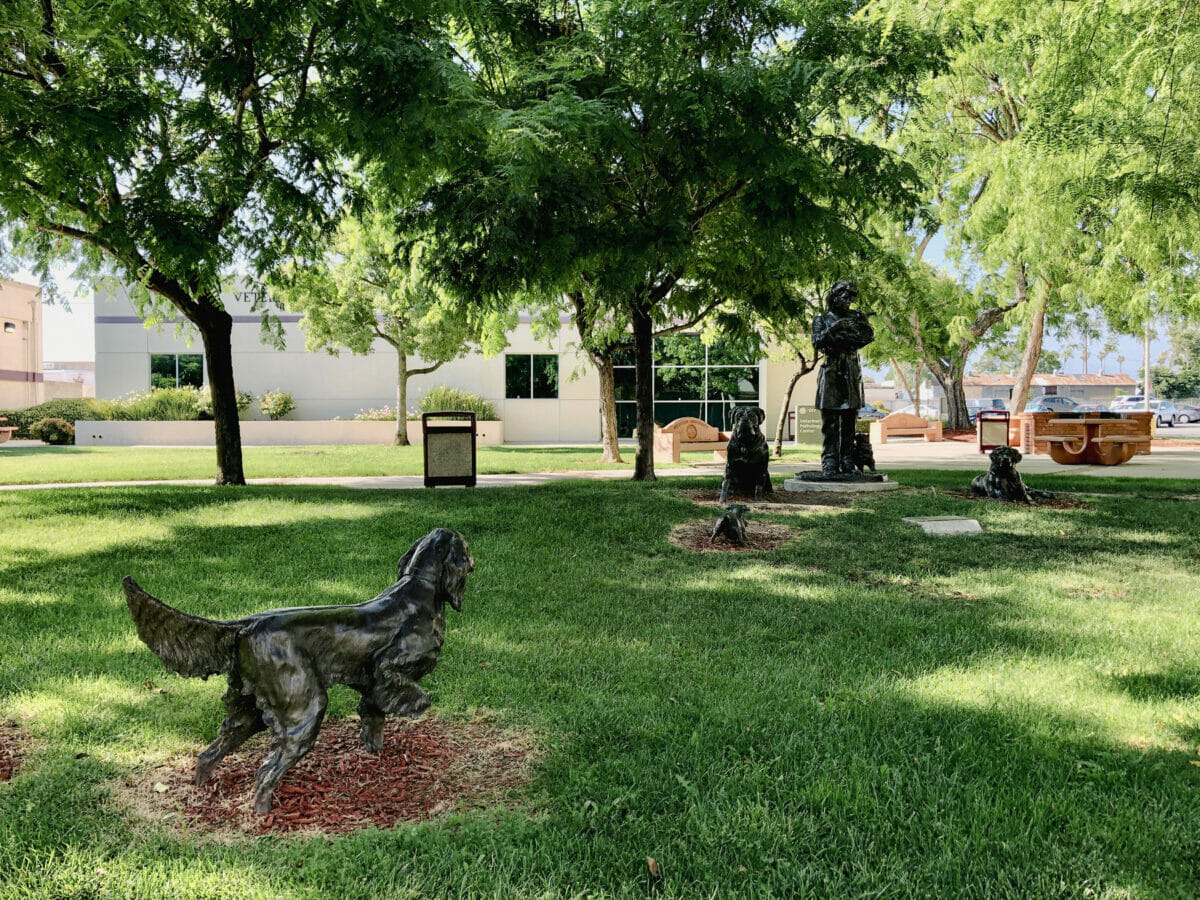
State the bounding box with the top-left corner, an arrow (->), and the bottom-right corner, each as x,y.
0,444 -> 820,485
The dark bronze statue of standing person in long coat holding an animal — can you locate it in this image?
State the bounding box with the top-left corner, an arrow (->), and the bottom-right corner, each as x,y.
812,281 -> 875,479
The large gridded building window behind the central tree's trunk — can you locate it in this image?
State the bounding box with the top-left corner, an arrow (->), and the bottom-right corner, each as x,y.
613,335 -> 762,438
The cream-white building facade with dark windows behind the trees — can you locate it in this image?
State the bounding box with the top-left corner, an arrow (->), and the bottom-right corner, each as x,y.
95,288 -> 816,443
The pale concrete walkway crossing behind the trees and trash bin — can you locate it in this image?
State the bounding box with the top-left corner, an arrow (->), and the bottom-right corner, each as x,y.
0,438 -> 1200,491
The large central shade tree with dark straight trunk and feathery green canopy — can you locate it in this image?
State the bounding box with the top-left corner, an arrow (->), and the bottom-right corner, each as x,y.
403,0 -> 930,480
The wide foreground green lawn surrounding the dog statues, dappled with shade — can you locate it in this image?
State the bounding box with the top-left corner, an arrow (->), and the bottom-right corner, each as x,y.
0,473 -> 1200,900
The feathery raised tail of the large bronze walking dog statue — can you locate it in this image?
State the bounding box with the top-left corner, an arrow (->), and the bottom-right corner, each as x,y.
121,575 -> 241,678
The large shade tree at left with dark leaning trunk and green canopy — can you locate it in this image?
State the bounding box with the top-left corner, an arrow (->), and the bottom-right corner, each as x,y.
0,0 -> 457,484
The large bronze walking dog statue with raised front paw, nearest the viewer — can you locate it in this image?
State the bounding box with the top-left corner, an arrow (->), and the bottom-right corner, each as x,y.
124,528 -> 475,812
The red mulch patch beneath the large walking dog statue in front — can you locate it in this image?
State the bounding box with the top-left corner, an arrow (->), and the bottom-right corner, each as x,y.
119,716 -> 535,835
